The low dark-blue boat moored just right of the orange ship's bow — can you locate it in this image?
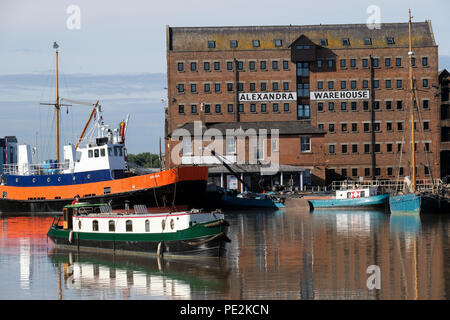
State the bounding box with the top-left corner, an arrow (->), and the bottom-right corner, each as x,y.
221,191 -> 285,208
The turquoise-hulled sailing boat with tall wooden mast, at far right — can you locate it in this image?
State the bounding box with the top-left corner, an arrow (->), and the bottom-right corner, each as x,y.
389,10 -> 439,215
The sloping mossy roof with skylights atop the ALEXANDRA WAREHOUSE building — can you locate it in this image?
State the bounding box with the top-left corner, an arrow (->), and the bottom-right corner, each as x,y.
167,20 -> 436,51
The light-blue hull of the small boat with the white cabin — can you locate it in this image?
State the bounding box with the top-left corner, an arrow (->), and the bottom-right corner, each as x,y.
308,194 -> 389,210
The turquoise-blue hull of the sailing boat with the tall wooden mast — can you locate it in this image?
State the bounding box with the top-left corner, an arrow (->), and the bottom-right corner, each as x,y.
389,193 -> 439,215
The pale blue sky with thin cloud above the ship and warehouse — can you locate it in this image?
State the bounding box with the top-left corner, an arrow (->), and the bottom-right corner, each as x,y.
0,0 -> 450,153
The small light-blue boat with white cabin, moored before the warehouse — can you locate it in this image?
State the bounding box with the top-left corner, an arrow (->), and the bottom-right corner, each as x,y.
308,187 -> 389,211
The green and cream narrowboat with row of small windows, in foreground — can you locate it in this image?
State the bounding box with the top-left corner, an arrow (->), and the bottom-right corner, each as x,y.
47,203 -> 230,257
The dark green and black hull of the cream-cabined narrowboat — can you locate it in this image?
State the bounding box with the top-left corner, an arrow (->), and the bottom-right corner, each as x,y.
47,222 -> 230,257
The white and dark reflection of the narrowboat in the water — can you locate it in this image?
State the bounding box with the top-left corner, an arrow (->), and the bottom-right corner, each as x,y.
49,249 -> 229,299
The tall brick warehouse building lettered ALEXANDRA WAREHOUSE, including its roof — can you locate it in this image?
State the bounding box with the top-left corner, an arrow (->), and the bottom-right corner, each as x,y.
166,21 -> 441,188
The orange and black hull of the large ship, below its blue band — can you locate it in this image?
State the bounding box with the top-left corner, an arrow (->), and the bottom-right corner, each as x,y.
0,167 -> 208,213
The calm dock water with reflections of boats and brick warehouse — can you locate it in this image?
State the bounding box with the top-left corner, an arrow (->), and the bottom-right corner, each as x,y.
0,209 -> 450,300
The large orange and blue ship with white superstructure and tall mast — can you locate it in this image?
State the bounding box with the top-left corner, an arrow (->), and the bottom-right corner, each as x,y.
0,42 -> 208,213
